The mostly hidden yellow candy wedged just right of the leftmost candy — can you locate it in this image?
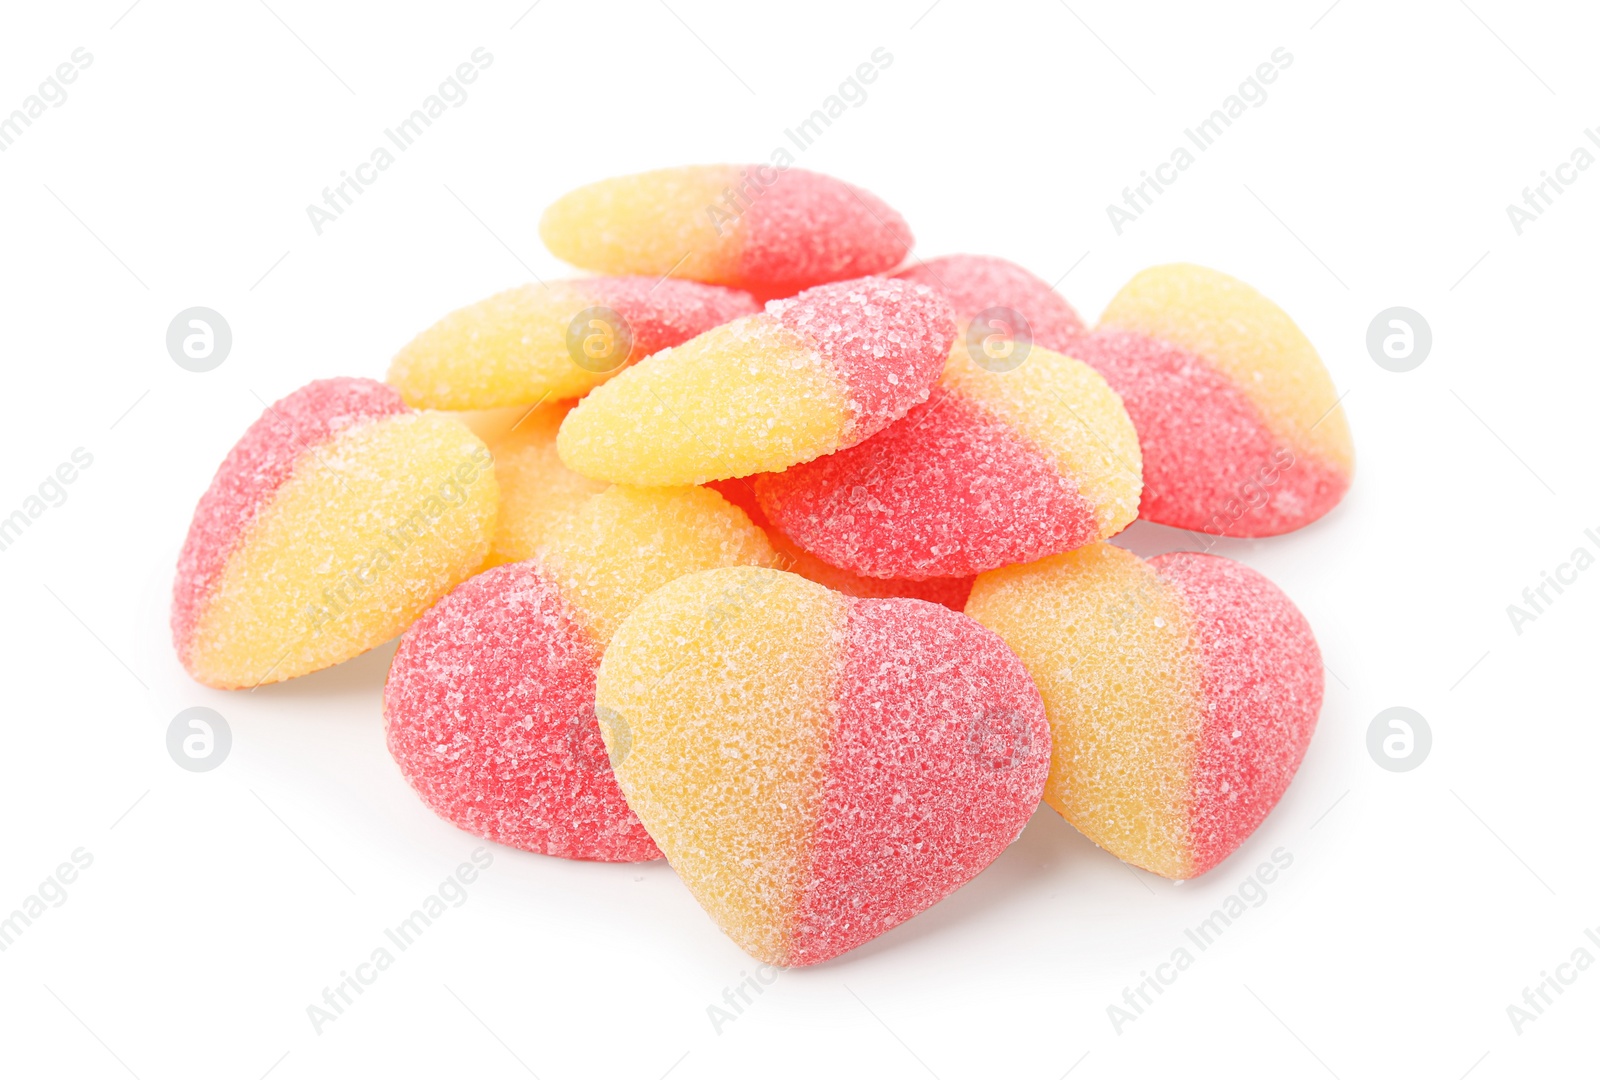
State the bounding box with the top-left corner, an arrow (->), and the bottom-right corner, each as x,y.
488,403 -> 606,565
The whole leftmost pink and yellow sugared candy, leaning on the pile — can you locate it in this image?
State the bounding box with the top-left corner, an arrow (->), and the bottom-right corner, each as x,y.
171,379 -> 499,690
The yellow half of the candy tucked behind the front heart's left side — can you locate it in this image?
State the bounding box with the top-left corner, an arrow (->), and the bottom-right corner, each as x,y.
539,485 -> 778,645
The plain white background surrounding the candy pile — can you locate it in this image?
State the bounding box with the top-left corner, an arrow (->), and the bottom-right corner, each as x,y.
0,0 -> 1600,1080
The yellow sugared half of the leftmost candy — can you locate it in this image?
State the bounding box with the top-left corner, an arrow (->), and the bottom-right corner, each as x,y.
174,401 -> 499,688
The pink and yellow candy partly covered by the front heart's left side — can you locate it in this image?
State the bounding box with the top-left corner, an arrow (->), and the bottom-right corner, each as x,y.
384,486 -> 774,861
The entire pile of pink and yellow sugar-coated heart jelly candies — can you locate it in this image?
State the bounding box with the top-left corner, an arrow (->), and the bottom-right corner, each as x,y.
171,166 -> 1354,965
